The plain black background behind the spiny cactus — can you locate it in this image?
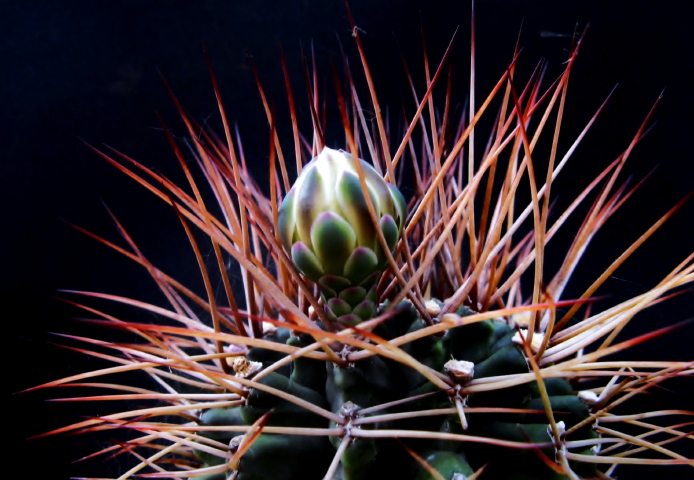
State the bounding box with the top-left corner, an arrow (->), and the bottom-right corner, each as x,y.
0,0 -> 694,479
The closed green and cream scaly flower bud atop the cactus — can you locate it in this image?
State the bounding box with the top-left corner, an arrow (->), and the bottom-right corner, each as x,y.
278,147 -> 407,324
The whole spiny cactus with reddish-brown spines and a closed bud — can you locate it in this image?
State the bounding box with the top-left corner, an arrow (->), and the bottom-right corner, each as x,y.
32,3 -> 694,480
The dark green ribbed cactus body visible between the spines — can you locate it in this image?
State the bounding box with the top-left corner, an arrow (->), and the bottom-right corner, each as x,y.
190,302 -> 595,480
